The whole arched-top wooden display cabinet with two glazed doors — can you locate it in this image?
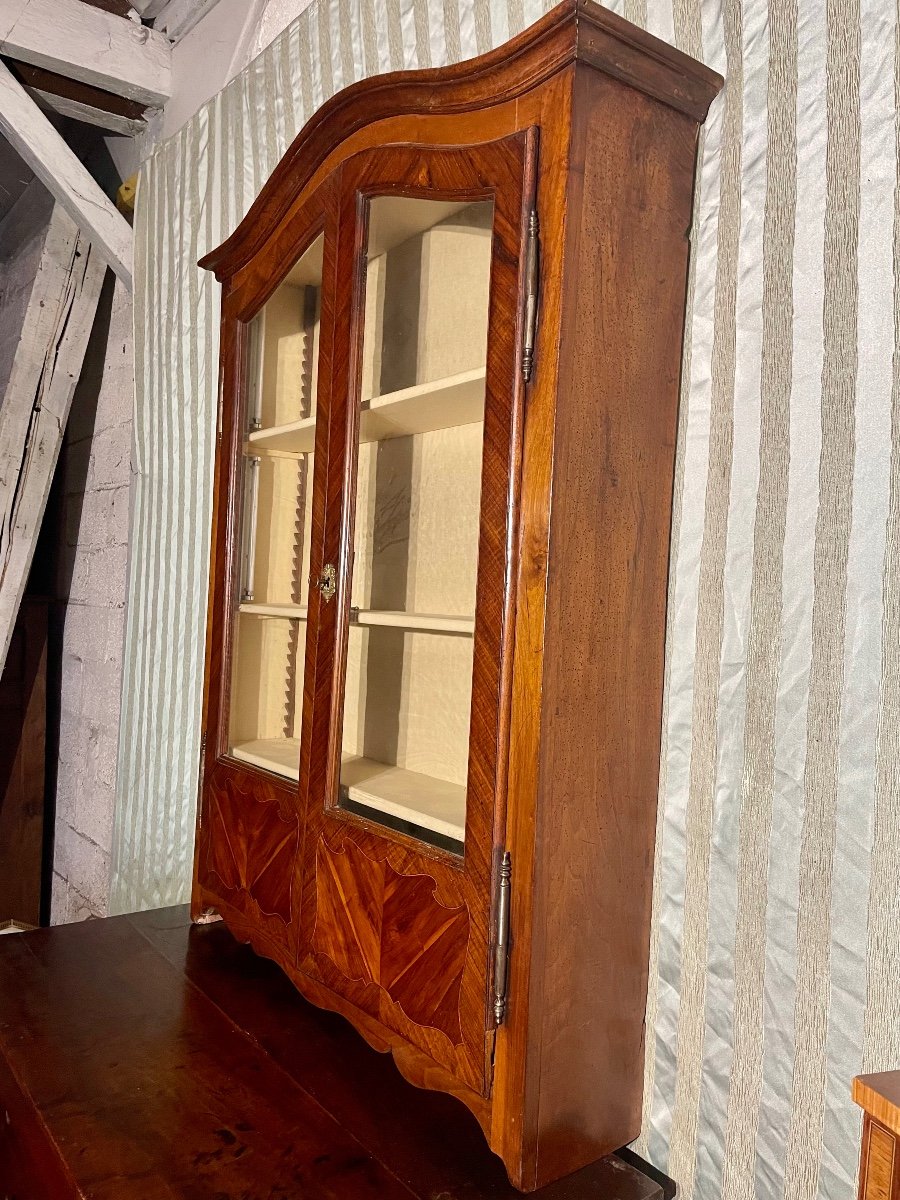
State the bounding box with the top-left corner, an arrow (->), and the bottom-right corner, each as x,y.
193,0 -> 721,1190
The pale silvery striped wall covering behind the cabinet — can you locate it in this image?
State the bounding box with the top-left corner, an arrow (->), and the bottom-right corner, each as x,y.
113,0 -> 900,1200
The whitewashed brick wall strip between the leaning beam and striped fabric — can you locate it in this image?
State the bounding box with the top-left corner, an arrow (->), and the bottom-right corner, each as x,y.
50,275 -> 134,924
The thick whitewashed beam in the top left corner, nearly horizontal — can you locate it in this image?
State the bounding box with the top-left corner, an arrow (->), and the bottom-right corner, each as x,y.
0,0 -> 172,107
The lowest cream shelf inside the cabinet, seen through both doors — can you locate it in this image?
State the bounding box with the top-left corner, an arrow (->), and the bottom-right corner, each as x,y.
226,738 -> 466,841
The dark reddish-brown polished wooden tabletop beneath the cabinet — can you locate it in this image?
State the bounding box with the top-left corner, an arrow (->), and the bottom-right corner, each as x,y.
0,908 -> 668,1200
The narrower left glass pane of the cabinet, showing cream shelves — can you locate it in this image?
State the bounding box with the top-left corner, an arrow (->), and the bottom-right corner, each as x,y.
229,236 -> 323,779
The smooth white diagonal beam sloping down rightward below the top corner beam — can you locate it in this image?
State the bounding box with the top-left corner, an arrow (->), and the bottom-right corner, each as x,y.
0,61 -> 133,290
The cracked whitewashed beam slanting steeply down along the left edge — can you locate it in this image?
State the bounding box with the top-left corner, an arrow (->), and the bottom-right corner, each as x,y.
0,204 -> 107,671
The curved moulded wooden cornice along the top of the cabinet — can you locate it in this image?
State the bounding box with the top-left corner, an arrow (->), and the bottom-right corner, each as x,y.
199,0 -> 724,281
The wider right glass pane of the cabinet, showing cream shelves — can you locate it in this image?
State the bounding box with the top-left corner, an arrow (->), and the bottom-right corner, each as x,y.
338,197 -> 493,853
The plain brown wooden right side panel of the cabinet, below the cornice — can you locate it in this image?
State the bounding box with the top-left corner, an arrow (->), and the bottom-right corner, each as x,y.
535,67 -> 697,1186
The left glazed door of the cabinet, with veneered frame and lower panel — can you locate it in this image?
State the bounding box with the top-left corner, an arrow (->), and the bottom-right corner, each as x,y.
197,176 -> 338,940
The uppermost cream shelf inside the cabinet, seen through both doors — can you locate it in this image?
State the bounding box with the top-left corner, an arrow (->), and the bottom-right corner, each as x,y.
247,367 -> 485,454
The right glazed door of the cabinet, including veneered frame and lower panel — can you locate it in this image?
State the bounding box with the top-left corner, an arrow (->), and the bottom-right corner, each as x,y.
299,134 -> 534,1093
